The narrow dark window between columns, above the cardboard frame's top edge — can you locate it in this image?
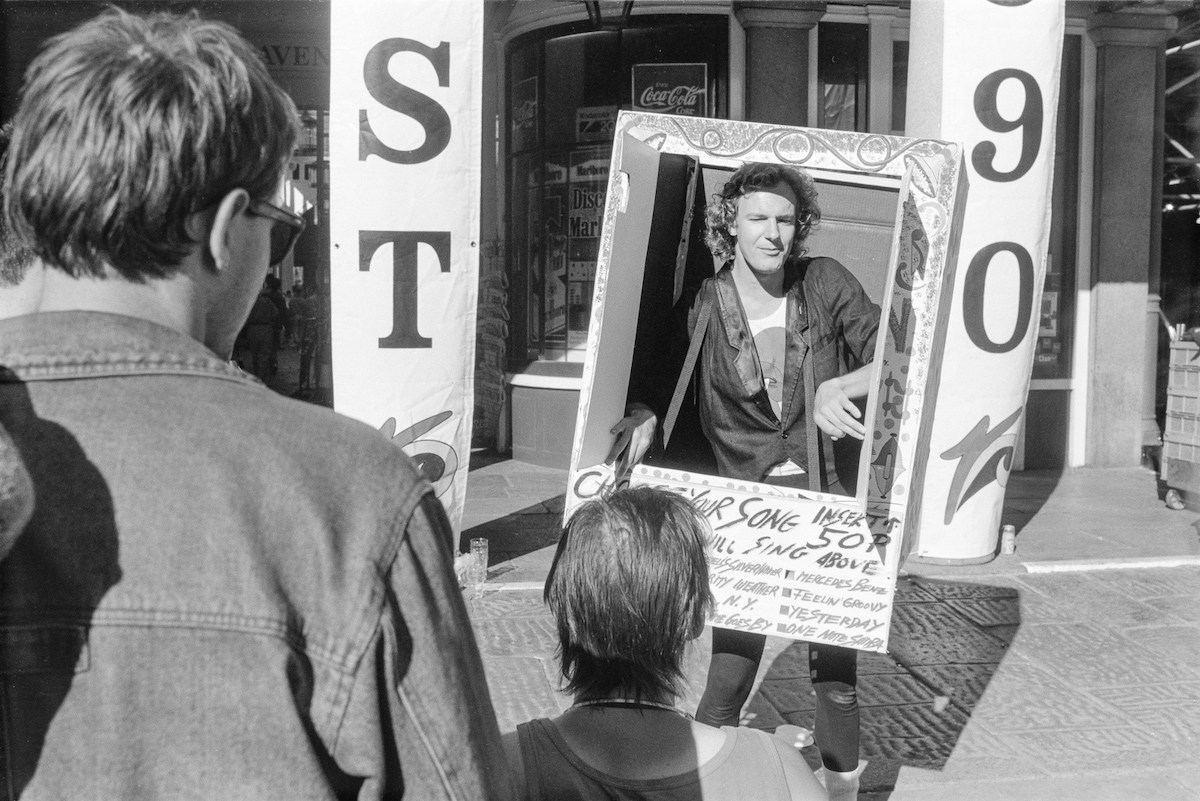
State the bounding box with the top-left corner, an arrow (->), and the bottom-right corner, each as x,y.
817,23 -> 868,131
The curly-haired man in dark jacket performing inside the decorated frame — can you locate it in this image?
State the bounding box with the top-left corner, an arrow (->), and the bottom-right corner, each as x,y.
608,163 -> 880,799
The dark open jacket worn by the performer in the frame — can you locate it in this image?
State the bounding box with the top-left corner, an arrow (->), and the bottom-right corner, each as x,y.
631,258 -> 880,489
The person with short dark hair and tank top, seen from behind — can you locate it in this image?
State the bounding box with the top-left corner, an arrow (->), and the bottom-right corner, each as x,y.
504,487 -> 826,801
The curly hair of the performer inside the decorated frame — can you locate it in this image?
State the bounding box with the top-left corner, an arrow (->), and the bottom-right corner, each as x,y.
704,162 -> 821,264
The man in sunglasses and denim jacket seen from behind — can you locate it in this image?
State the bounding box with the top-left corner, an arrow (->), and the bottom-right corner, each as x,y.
0,10 -> 511,799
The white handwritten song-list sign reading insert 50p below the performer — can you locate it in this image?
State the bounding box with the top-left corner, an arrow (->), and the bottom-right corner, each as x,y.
629,465 -> 895,652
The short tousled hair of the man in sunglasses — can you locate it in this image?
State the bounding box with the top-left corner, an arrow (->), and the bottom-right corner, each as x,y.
4,8 -> 299,282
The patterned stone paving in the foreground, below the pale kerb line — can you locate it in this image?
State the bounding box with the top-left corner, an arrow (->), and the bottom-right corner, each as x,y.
470,567 -> 1200,801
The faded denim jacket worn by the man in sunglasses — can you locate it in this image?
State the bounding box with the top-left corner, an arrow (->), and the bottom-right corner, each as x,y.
0,312 -> 511,800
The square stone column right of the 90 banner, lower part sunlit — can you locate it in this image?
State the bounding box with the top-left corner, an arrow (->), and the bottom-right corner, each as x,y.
1086,8 -> 1176,466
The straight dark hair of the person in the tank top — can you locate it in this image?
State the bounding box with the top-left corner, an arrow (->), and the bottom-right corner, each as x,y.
545,487 -> 714,699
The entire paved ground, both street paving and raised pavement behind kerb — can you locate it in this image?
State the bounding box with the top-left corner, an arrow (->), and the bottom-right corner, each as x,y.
462,454 -> 1200,801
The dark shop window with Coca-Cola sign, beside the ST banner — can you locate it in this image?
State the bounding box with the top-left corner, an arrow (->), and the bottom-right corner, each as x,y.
506,16 -> 728,369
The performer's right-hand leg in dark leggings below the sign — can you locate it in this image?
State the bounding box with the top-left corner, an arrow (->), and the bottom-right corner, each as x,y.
811,642 -> 858,772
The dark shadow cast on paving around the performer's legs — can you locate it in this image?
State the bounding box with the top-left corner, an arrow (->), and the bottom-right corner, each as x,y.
746,577 -> 1021,800
